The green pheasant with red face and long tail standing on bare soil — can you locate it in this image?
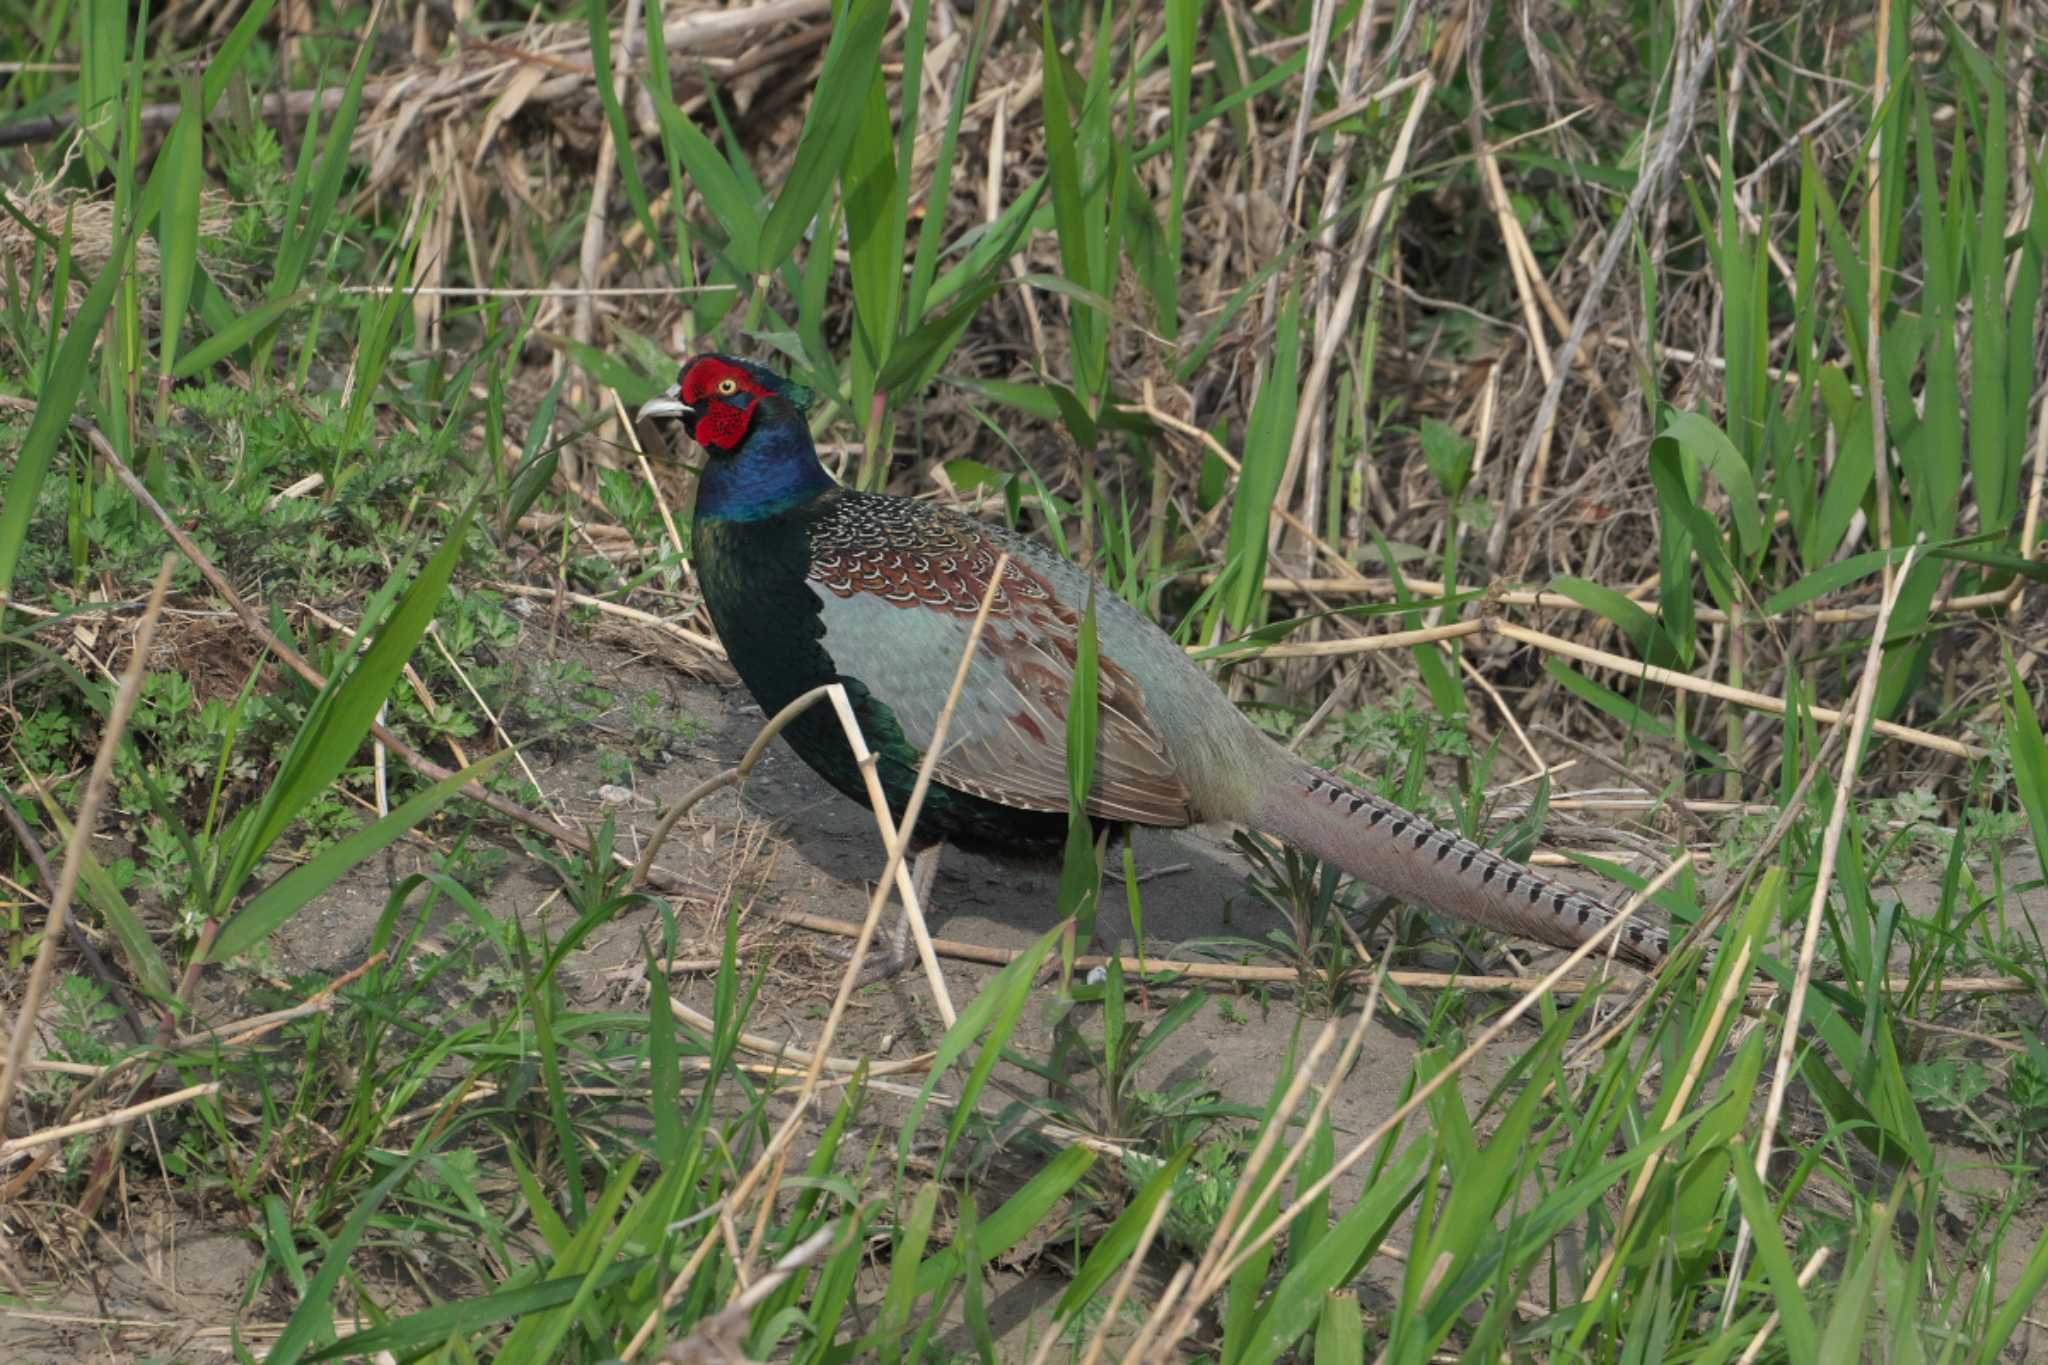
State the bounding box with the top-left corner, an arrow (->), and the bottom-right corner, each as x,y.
639,354 -> 1667,966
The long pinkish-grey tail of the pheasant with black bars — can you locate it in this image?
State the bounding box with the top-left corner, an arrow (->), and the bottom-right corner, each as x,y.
1251,763 -> 1671,968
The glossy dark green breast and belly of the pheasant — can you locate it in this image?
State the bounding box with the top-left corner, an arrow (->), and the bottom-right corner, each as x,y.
692,489 -> 1067,857
